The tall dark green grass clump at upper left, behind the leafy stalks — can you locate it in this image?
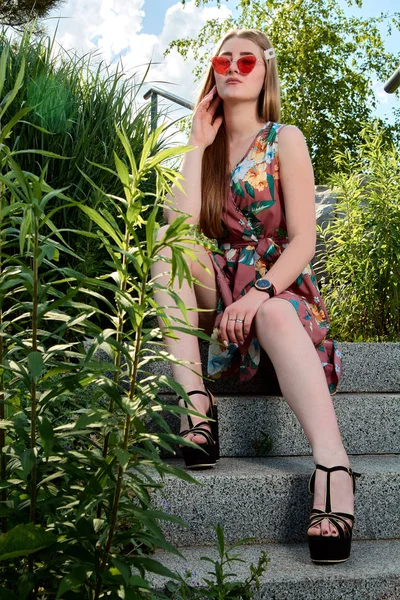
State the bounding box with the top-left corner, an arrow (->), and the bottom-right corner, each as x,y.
0,28 -> 175,276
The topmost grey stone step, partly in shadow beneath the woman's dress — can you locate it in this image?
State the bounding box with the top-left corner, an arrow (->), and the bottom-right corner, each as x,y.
144,342 -> 400,395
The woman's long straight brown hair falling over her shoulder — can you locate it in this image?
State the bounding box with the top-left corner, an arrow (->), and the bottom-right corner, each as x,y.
196,29 -> 280,238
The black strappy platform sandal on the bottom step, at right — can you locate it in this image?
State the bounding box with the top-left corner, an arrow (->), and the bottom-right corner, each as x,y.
307,465 -> 361,564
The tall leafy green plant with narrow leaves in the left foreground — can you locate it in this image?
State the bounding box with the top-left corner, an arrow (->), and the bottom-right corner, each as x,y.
0,44 -> 219,600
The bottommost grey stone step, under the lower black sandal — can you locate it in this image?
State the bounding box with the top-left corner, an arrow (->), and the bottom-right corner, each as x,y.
153,540 -> 400,600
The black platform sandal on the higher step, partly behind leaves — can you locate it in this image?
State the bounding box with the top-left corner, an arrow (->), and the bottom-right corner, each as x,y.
179,388 -> 219,469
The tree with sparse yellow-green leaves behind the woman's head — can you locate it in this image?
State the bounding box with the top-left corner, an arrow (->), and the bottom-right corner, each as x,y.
166,0 -> 400,184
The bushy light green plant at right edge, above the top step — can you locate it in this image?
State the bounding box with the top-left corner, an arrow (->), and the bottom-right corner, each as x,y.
317,123 -> 400,342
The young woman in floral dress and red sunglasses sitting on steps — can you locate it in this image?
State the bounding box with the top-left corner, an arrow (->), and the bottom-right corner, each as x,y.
153,29 -> 358,562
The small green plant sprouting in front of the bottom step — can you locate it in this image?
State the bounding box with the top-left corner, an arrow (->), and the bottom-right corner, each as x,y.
164,523 -> 270,600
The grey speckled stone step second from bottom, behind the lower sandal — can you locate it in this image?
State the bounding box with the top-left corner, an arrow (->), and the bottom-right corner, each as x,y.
155,455 -> 400,546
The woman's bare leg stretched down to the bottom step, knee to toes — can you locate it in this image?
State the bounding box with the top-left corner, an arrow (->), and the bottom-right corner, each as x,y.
255,298 -> 354,536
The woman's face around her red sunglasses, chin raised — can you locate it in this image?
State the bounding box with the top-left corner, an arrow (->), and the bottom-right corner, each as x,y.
214,38 -> 265,102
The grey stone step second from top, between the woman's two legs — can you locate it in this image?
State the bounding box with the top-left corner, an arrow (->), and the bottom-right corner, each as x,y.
159,394 -> 400,456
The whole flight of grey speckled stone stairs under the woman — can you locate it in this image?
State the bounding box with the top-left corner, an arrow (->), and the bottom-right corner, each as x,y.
151,343 -> 400,600
